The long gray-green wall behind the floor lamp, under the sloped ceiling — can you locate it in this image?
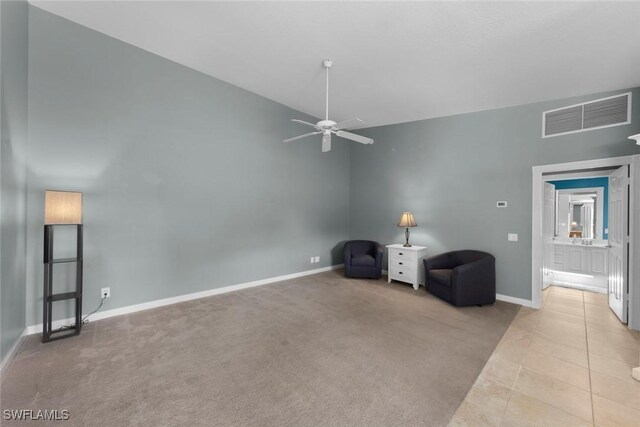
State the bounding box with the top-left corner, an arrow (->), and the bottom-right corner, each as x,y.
27,7 -> 349,325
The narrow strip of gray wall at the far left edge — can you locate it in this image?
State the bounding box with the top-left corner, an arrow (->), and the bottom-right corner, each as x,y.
0,1 -> 29,359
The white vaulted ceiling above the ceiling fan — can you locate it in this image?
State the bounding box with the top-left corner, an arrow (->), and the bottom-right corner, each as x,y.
31,1 -> 640,127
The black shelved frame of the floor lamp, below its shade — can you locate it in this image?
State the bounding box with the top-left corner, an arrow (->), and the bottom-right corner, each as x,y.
42,224 -> 82,343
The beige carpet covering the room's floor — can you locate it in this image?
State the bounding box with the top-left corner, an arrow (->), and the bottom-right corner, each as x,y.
1,271 -> 519,426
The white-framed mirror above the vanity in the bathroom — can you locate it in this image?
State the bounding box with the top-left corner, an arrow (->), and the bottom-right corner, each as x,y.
556,188 -> 606,239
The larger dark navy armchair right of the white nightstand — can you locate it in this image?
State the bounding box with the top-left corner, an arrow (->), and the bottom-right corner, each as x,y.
423,250 -> 496,306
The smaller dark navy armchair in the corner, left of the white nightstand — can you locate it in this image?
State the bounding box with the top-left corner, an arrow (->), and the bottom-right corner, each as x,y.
344,240 -> 384,279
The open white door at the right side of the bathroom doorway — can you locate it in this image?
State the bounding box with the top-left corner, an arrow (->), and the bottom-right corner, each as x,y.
609,166 -> 629,323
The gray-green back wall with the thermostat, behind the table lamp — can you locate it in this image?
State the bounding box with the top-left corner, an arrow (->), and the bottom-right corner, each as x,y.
349,88 -> 640,299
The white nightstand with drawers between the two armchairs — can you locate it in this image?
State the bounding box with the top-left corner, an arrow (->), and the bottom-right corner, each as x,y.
387,244 -> 427,289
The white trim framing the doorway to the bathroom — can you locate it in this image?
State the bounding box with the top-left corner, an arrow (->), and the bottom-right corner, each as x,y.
531,154 -> 640,330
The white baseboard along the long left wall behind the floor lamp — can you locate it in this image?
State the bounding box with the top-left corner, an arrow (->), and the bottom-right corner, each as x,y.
25,264 -> 344,335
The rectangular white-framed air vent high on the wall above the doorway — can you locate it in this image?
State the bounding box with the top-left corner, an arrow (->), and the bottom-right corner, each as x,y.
542,92 -> 631,138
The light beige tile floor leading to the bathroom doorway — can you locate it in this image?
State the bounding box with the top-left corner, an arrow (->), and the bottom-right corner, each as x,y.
449,286 -> 640,427
